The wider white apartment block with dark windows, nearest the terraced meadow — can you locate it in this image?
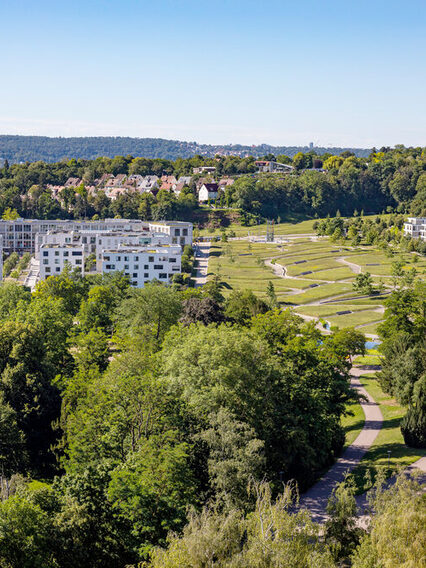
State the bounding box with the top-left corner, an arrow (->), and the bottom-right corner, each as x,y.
102,245 -> 182,288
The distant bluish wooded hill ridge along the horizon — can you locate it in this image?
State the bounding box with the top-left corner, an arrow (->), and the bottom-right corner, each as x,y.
0,135 -> 371,163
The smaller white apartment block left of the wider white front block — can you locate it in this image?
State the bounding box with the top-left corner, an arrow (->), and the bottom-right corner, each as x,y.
40,244 -> 84,280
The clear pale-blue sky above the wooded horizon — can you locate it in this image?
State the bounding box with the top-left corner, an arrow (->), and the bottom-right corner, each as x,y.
0,0 -> 426,147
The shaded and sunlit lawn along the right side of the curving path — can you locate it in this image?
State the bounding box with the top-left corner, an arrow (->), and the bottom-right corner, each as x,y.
352,375 -> 426,493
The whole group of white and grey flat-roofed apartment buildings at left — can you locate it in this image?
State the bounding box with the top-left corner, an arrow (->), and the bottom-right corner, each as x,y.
0,219 -> 193,288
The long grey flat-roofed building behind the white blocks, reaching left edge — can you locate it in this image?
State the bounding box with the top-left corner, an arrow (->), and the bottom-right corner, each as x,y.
0,219 -> 149,253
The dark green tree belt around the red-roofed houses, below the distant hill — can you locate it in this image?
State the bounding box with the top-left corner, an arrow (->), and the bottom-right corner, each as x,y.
0,147 -> 426,223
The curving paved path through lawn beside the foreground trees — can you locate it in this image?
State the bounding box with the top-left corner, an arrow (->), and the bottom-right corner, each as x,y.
299,367 -> 383,523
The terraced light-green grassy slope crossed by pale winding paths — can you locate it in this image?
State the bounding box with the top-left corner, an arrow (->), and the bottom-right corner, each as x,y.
206,220 -> 426,335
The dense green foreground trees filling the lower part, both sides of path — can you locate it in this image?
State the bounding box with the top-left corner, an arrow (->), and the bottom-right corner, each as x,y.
0,271 -> 426,568
